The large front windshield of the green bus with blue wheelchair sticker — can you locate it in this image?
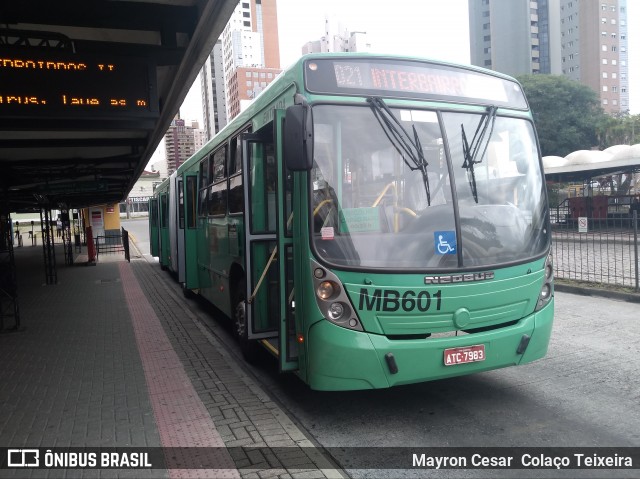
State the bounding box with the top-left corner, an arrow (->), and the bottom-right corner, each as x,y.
310,104 -> 550,270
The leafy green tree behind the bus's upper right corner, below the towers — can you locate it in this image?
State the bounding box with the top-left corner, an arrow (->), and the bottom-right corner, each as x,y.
518,75 -> 606,156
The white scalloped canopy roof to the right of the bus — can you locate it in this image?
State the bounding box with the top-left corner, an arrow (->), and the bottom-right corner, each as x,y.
542,144 -> 640,183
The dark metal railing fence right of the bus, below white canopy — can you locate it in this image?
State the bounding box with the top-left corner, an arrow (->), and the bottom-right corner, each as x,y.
552,212 -> 640,292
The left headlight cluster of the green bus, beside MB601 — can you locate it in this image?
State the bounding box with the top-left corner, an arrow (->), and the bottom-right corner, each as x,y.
312,261 -> 364,331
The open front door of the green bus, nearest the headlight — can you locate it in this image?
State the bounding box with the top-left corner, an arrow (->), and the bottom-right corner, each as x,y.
242,110 -> 298,371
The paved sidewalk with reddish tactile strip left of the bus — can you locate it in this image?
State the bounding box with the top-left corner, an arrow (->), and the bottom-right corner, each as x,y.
0,247 -> 345,478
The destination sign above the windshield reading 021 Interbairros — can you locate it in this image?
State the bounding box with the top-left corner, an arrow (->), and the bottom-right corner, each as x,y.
305,58 -> 527,109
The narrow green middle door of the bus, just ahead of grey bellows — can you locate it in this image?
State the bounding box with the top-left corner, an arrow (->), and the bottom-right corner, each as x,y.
182,172 -> 198,290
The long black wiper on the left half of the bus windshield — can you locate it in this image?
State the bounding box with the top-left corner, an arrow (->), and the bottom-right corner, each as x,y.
367,97 -> 431,206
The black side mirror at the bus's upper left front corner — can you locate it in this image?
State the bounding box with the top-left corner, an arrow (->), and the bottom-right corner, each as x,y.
284,105 -> 313,171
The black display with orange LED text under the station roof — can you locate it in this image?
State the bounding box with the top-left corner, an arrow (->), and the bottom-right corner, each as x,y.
0,49 -> 158,119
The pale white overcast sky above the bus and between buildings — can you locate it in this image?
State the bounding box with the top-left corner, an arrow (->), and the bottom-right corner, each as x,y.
161,0 -> 640,169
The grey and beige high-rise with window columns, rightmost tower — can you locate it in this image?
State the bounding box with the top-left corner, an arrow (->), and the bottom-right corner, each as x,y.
560,0 -> 629,113
